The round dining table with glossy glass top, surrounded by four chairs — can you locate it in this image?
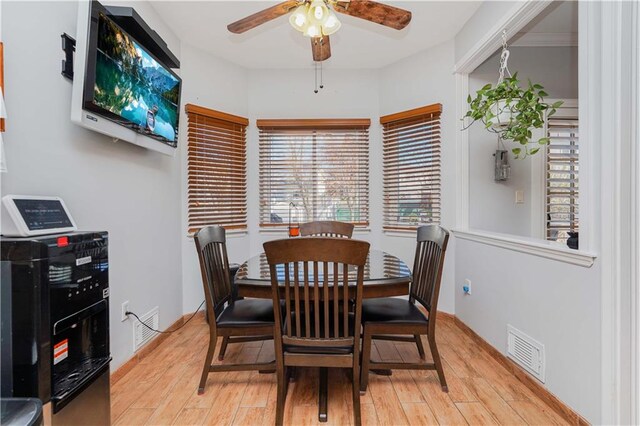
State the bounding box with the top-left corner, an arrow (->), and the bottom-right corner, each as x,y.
235,250 -> 411,422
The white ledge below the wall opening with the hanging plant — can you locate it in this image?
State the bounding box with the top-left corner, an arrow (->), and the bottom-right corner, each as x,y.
453,230 -> 597,268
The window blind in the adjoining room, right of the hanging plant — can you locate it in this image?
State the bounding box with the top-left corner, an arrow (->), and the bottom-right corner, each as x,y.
546,118 -> 579,242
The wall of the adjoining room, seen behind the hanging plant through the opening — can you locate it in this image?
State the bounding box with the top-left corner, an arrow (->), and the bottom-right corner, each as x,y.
469,47 -> 578,237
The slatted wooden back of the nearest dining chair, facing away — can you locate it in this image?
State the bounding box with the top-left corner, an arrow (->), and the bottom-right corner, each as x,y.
264,237 -> 369,347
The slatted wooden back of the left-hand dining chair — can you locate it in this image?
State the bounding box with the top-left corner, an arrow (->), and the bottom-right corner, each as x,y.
194,226 -> 233,323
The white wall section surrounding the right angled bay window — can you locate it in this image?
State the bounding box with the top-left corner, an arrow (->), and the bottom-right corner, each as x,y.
372,40 -> 460,313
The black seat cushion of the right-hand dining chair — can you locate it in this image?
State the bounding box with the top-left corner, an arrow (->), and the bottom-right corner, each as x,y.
362,297 -> 428,325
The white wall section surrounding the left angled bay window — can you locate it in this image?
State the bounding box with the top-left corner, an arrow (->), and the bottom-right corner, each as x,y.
180,43 -> 253,314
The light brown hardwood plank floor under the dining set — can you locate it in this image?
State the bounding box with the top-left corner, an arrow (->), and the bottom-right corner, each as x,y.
111,316 -> 566,426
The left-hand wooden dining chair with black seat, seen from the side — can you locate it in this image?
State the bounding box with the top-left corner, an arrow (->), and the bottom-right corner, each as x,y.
194,226 -> 275,395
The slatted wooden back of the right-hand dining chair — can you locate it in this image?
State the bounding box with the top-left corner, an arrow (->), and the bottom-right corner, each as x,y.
409,225 -> 449,316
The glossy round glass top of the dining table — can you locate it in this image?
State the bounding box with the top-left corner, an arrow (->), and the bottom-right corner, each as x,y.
235,250 -> 411,282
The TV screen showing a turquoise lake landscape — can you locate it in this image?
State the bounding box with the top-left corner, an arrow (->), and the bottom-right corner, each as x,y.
90,12 -> 181,147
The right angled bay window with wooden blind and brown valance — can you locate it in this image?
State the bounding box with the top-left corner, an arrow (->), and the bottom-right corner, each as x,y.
380,104 -> 442,230
